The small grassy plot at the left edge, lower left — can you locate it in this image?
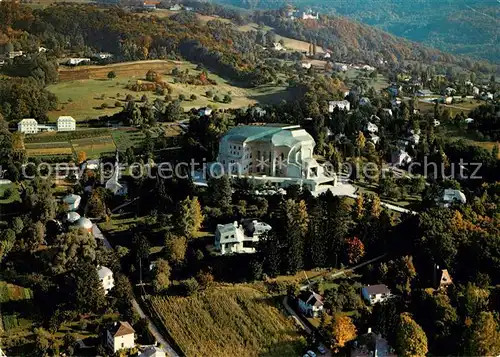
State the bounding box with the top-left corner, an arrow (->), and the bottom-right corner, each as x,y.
0,281 -> 33,334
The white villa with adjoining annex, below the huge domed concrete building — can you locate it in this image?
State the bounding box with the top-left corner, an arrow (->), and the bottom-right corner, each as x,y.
214,220 -> 272,255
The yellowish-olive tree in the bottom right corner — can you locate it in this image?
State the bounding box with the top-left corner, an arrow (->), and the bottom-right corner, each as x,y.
467,311 -> 500,356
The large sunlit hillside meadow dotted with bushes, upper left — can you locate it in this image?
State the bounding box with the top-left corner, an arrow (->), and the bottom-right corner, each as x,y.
48,61 -> 289,121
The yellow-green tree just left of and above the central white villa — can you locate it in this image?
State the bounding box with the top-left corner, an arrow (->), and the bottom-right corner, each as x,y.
174,197 -> 204,237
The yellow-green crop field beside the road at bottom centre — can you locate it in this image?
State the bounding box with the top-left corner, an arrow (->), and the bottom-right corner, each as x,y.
152,285 -> 303,357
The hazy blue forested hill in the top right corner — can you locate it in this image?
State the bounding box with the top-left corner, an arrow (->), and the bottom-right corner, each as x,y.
212,0 -> 500,63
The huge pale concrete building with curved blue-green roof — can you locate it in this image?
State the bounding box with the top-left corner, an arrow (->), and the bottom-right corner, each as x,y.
217,125 -> 336,191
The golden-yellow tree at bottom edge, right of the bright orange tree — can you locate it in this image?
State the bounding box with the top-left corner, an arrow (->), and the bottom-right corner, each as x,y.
395,312 -> 428,357
